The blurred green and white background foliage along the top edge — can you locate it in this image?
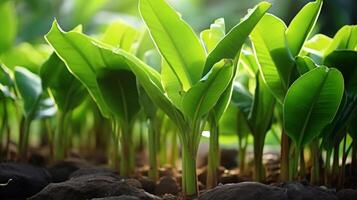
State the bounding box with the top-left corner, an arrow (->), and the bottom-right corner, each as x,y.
0,0 -> 357,47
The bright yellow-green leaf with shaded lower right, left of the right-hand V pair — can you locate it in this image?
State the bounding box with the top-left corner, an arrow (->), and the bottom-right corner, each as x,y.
251,14 -> 294,103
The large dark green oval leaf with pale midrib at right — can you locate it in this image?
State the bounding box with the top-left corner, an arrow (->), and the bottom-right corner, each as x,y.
284,66 -> 344,149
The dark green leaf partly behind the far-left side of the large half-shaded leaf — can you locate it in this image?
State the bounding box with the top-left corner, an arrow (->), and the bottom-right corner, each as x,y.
41,53 -> 87,112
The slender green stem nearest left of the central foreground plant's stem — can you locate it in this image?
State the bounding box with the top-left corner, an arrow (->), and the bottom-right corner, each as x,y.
148,119 -> 159,181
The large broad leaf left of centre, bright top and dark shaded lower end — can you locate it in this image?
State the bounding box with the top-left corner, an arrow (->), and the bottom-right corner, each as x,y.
46,21 -> 139,123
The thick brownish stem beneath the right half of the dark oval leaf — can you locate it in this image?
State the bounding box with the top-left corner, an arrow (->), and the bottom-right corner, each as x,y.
310,139 -> 320,185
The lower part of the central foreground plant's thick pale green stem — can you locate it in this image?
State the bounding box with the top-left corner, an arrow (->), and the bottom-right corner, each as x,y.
182,144 -> 198,199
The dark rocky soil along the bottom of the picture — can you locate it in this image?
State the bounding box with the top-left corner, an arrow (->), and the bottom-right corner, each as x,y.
0,152 -> 357,200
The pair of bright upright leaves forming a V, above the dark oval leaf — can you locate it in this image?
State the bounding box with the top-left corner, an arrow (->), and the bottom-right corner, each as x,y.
251,0 -> 322,104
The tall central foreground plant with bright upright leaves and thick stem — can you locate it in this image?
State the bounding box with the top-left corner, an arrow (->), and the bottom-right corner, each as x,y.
136,0 -> 270,195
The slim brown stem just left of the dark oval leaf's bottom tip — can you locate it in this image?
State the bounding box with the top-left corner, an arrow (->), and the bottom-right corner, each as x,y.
280,128 -> 290,181
